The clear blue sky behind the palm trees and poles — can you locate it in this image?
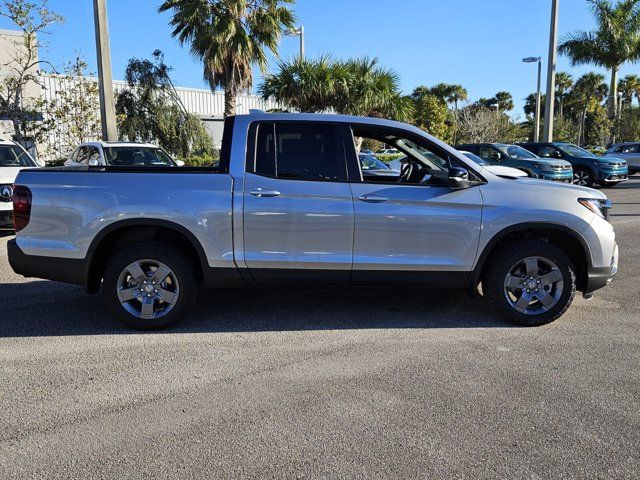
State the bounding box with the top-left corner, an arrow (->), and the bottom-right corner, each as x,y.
0,0 -> 640,116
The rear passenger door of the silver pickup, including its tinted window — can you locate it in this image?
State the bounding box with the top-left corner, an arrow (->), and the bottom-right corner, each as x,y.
243,122 -> 354,284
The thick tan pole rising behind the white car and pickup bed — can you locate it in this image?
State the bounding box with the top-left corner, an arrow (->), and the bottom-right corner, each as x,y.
93,0 -> 118,142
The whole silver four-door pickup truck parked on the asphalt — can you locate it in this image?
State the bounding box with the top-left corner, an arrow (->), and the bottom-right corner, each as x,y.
8,112 -> 618,329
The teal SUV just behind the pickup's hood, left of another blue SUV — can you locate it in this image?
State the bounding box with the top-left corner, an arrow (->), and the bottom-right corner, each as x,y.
457,143 -> 573,183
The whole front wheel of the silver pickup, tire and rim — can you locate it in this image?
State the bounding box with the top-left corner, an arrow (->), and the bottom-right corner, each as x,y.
483,239 -> 576,326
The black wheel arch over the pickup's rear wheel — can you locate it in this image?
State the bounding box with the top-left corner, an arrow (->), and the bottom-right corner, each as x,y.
85,218 -> 208,293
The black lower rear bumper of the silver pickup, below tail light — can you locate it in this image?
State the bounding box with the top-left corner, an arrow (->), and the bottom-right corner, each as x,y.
7,239 -> 87,285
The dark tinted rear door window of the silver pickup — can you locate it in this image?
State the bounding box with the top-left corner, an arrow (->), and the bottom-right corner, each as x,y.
254,122 -> 346,182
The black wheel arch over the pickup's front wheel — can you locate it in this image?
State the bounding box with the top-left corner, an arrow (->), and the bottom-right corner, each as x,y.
466,222 -> 593,294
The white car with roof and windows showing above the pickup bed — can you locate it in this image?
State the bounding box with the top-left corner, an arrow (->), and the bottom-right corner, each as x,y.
65,142 -> 184,167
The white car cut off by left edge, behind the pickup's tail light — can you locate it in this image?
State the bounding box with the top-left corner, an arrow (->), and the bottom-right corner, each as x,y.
0,139 -> 39,228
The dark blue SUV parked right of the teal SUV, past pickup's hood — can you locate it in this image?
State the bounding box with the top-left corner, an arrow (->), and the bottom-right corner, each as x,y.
518,142 -> 629,187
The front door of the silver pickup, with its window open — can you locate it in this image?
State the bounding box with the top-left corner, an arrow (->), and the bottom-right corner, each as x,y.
344,127 -> 482,286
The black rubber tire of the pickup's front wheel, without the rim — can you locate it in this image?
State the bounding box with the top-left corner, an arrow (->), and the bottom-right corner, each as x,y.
482,238 -> 576,326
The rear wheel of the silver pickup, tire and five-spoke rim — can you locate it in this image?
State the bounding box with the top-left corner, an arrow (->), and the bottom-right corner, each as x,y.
101,242 -> 198,330
